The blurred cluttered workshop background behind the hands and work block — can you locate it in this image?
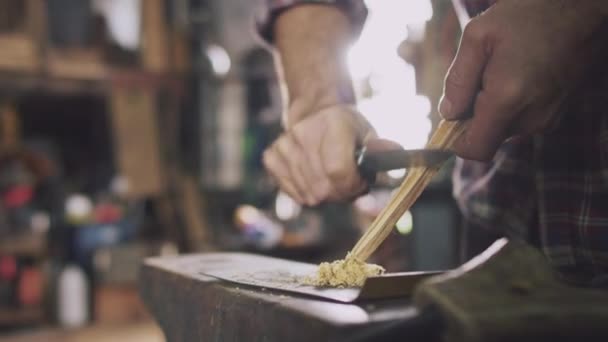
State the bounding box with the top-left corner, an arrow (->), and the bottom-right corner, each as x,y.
0,0 -> 461,341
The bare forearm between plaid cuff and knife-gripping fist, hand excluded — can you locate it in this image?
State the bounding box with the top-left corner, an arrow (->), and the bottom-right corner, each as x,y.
274,4 -> 355,126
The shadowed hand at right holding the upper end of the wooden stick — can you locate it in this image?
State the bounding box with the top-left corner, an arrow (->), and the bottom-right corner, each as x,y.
439,0 -> 608,160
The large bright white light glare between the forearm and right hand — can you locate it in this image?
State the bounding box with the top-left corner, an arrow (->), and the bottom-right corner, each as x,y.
347,0 -> 433,149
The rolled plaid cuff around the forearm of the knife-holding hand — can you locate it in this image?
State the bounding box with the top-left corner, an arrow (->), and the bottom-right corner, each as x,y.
257,0 -> 367,43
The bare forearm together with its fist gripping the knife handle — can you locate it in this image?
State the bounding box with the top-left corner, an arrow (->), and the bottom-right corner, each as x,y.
264,3 -> 375,206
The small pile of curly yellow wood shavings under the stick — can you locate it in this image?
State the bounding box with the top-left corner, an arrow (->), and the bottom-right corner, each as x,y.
305,254 -> 384,288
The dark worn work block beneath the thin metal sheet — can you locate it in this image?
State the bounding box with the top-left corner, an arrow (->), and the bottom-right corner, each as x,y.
140,255 -> 432,341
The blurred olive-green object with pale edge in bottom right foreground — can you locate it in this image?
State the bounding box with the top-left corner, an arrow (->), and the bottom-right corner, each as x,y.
414,239 -> 608,342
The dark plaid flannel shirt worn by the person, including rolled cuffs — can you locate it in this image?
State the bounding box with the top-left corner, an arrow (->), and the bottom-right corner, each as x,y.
268,0 -> 608,283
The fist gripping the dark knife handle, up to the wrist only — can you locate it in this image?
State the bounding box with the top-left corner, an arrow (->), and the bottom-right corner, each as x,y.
264,105 -> 376,206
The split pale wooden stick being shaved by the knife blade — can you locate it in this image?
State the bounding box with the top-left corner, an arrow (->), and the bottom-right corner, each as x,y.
350,121 -> 468,261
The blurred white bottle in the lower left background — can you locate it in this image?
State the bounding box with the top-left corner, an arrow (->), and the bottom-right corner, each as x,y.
57,264 -> 89,328
